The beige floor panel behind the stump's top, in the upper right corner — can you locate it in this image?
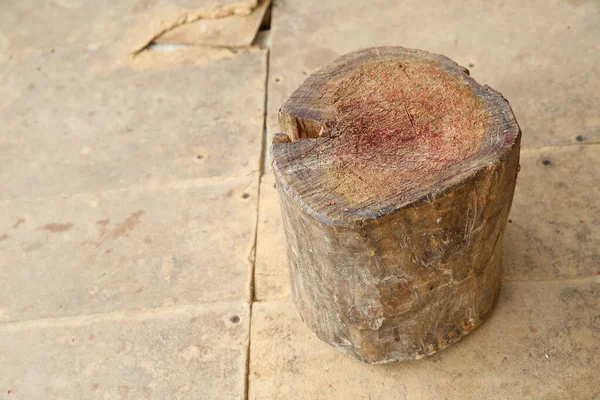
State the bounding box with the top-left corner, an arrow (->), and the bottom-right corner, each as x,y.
268,0 -> 600,174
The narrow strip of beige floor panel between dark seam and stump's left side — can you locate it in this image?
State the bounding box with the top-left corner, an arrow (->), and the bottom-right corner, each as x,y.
254,174 -> 290,301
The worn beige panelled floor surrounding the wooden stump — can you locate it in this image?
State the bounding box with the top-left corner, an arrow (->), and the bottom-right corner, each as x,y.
0,0 -> 600,400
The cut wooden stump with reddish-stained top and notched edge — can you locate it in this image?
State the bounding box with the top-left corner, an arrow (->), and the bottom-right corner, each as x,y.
271,47 -> 521,363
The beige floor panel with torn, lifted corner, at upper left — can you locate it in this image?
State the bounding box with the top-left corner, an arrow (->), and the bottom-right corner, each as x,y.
0,0 -> 266,199
